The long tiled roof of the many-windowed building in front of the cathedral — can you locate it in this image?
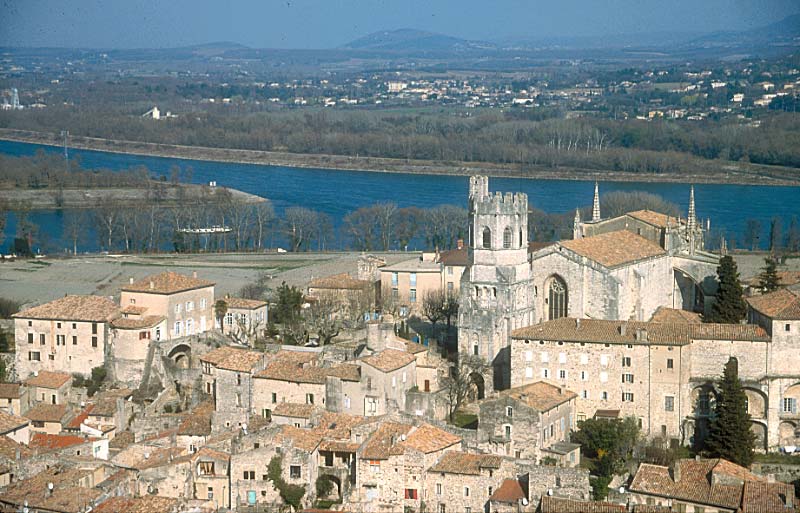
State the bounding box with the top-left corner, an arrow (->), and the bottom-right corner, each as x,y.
511,317 -> 770,345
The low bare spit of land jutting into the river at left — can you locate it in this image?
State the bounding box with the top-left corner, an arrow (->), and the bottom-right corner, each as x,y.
0,182 -> 265,210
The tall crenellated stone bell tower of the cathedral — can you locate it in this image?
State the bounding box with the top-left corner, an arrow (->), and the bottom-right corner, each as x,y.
458,176 -> 534,389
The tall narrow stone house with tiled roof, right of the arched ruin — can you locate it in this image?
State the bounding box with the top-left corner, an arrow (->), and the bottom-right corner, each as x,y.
200,347 -> 266,431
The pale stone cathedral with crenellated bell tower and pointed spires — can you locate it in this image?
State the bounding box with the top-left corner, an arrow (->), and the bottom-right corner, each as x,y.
458,176 -> 718,390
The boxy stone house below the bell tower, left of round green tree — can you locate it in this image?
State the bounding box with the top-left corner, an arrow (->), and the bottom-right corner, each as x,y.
478,381 -> 580,466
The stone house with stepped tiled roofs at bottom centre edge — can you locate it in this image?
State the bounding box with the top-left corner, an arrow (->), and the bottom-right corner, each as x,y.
351,421 -> 461,511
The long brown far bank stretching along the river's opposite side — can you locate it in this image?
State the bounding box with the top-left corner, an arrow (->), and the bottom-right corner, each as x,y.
0,128 -> 800,186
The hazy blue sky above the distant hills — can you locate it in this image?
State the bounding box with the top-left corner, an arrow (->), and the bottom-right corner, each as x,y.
0,0 -> 800,48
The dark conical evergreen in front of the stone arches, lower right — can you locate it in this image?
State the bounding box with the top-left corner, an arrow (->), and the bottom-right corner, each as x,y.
705,358 -> 756,467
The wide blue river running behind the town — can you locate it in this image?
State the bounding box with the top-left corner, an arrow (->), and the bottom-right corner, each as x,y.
0,141 -> 800,252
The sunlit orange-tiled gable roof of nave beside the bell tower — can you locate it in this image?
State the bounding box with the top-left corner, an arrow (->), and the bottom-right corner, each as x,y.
560,230 -> 667,267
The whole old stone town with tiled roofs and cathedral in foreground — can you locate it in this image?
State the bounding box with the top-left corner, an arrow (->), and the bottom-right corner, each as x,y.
0,176 -> 800,513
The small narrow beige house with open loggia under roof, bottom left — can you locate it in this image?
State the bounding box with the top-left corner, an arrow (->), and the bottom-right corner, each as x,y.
190,447 -> 231,511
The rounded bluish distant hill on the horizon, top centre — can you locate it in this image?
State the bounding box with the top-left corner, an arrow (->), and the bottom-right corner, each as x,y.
342,29 -> 496,52
